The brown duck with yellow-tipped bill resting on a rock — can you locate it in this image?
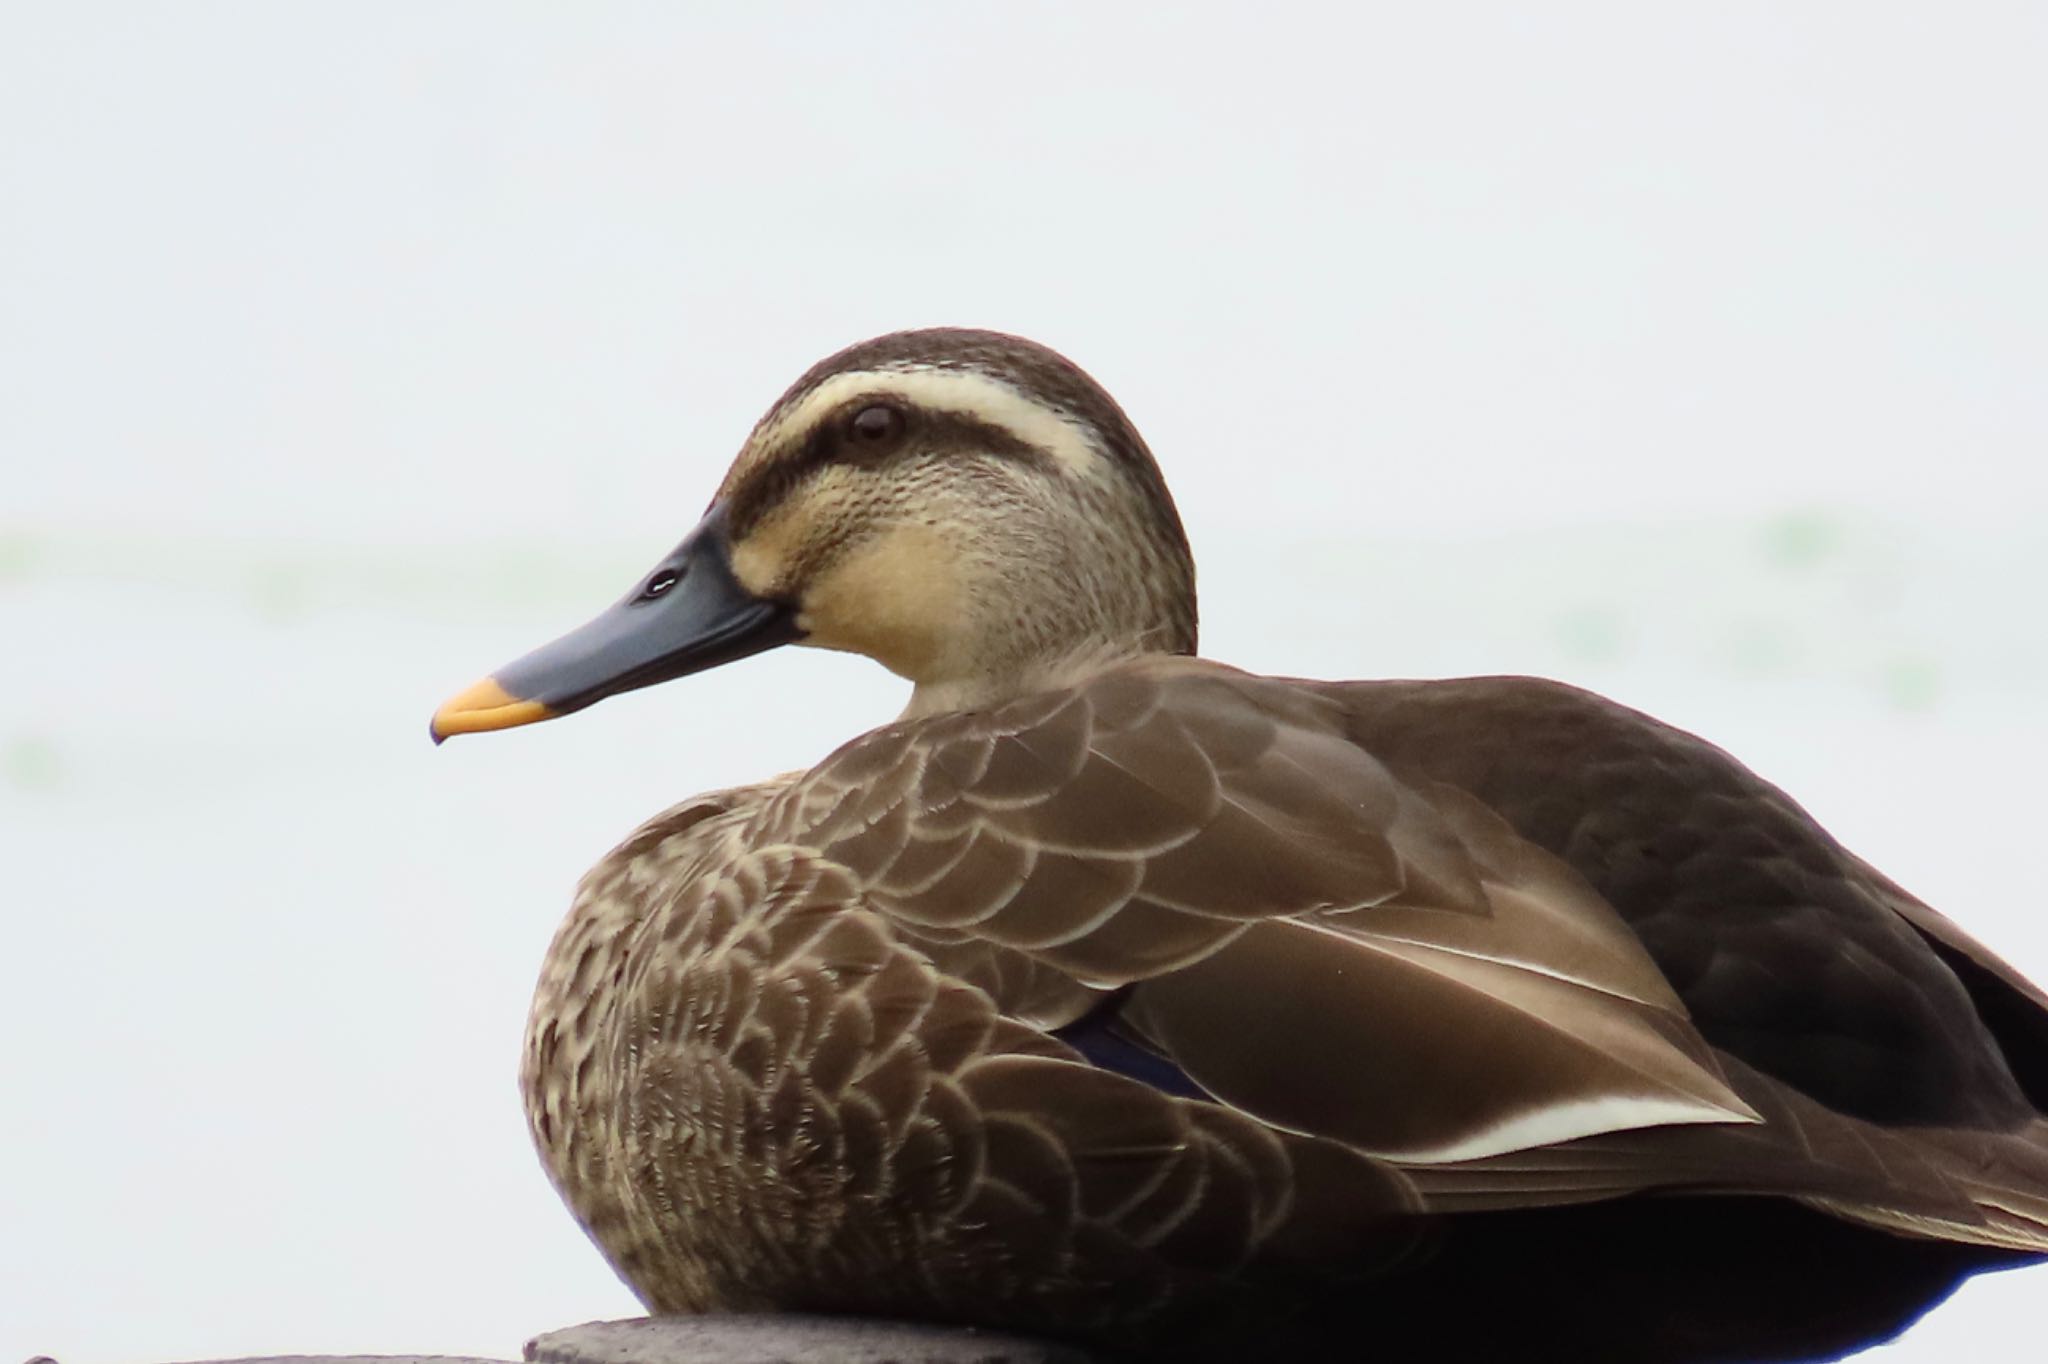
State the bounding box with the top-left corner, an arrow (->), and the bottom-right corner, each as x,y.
432,328 -> 2048,1364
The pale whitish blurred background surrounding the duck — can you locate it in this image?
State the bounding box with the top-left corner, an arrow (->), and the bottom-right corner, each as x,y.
0,0 -> 2048,1364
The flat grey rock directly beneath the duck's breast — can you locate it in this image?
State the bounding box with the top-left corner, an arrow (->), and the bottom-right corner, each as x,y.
526,1315 -> 1112,1364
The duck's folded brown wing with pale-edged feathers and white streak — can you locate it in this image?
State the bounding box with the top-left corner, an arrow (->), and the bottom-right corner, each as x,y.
756,659 -> 2048,1249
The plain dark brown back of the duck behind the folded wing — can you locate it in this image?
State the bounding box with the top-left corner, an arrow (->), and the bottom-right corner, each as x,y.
1321,678 -> 2048,1131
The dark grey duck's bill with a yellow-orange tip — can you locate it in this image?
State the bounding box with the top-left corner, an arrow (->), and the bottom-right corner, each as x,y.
430,499 -> 803,743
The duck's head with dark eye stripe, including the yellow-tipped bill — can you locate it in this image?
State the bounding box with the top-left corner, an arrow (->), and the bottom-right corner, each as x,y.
432,330 -> 1194,741
